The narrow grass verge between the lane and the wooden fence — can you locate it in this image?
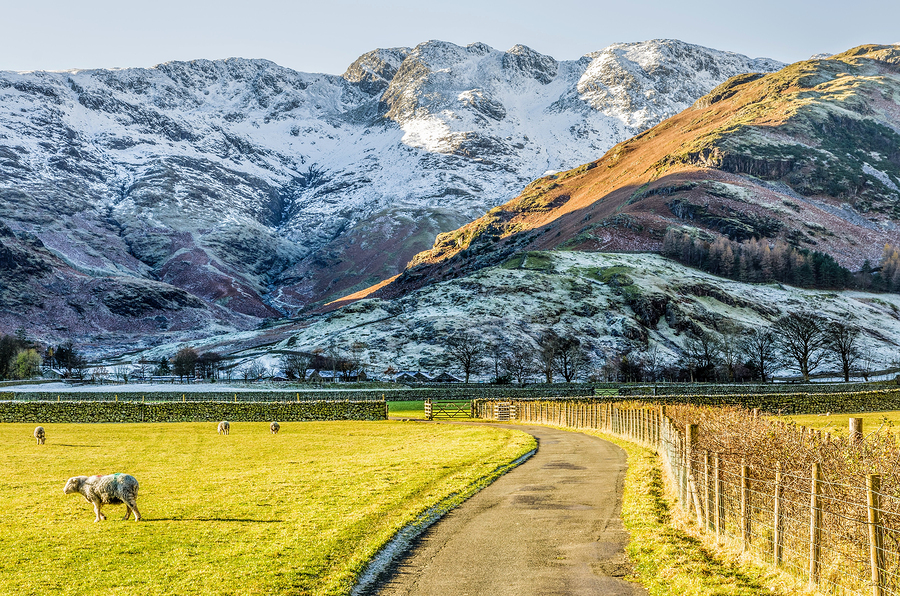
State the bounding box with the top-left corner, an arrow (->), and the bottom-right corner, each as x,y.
536,428 -> 804,596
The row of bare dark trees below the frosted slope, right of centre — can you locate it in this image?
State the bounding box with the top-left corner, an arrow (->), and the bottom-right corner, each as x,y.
444,312 -> 874,384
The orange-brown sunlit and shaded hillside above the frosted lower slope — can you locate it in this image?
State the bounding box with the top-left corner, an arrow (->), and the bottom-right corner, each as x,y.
379,46 -> 900,296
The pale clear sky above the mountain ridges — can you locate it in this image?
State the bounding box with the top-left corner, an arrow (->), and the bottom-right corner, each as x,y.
0,0 -> 900,74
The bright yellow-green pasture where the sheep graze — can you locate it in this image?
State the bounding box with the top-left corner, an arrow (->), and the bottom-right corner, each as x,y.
0,422 -> 533,596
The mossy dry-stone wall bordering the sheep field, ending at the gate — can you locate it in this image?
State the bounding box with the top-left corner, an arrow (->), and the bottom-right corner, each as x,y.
0,401 -> 387,424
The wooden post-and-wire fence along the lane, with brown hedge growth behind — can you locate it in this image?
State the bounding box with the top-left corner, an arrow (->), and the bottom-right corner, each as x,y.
473,398 -> 900,596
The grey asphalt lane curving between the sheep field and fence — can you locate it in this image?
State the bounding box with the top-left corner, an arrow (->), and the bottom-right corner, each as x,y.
374,425 -> 647,596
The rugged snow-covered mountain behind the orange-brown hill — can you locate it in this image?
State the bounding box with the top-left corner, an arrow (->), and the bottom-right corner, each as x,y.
0,40 -> 782,350
